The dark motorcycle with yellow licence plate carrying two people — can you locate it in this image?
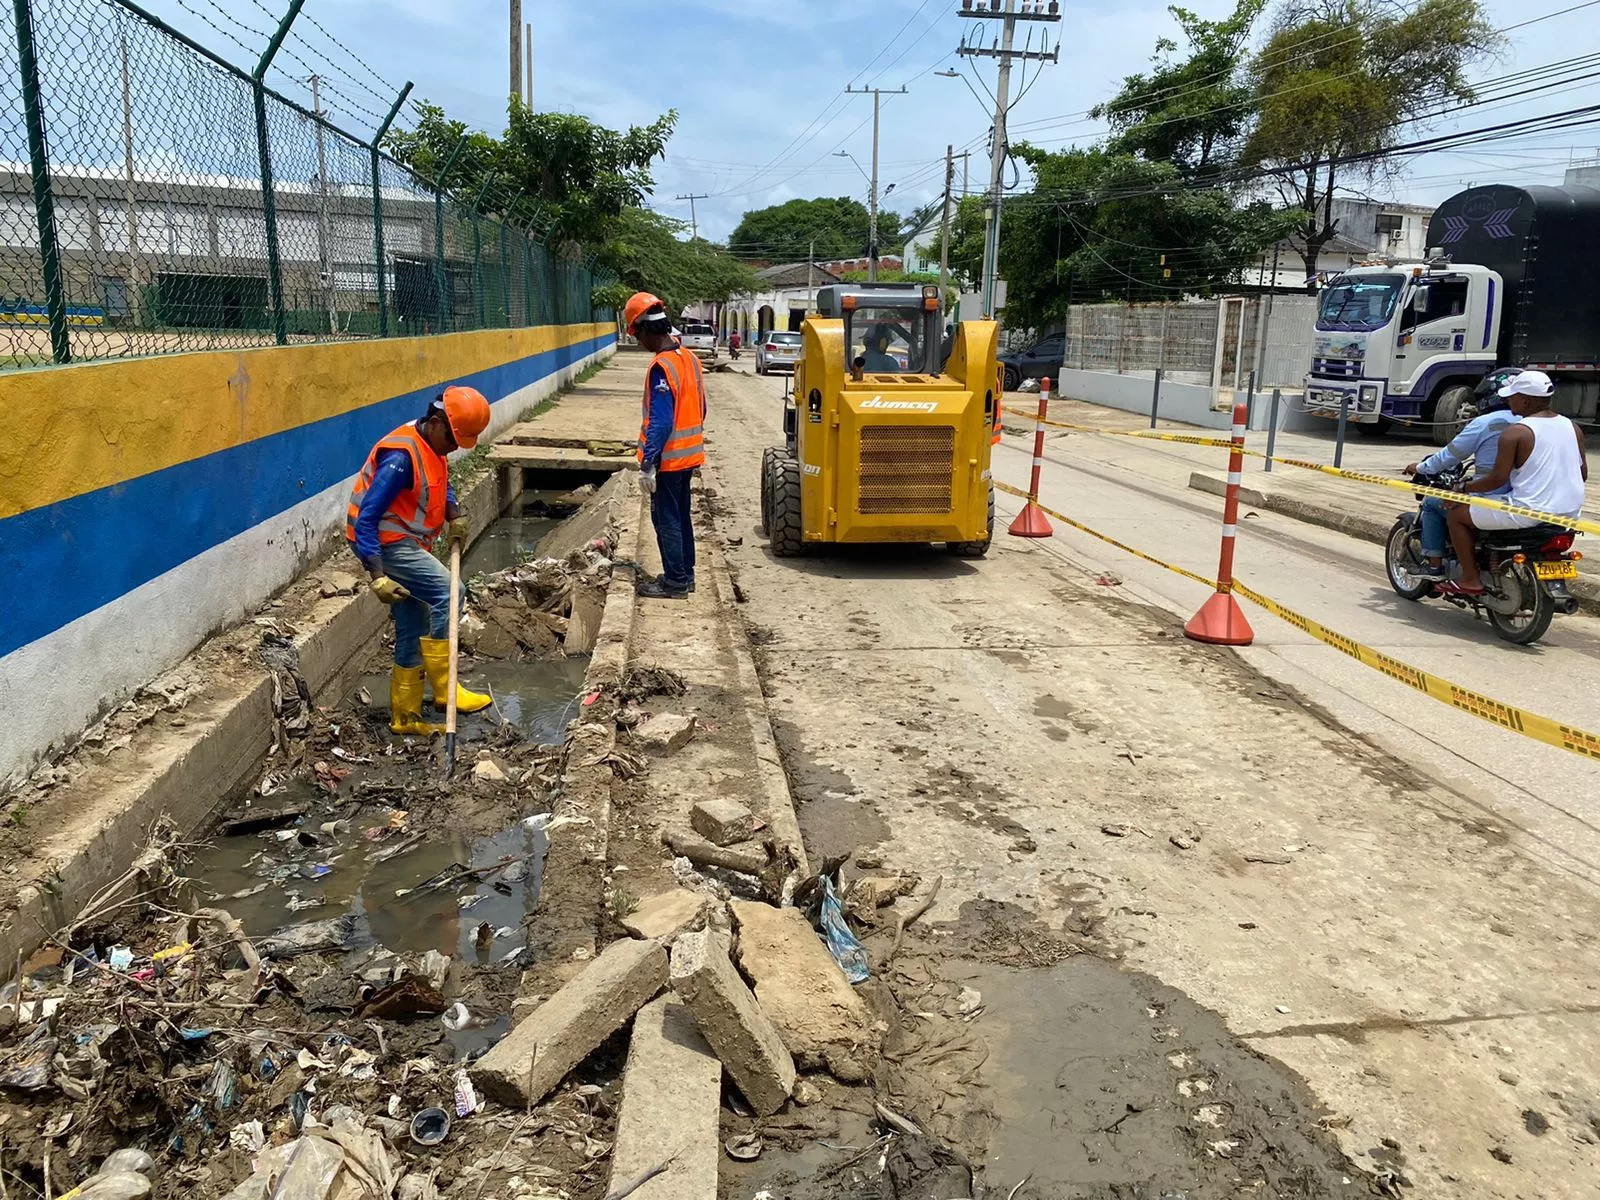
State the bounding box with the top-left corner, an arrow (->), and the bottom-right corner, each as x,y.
1384,467 -> 1582,646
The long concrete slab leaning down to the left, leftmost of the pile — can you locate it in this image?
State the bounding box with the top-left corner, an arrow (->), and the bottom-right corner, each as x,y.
470,939 -> 667,1109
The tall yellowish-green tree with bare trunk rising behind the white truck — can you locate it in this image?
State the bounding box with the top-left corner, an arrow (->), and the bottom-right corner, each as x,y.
1240,0 -> 1501,275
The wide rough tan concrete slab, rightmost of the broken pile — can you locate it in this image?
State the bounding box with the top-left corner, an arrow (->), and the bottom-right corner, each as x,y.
731,901 -> 875,1083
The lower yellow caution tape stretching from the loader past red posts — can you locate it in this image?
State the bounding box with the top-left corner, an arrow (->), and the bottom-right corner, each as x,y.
995,480 -> 1600,762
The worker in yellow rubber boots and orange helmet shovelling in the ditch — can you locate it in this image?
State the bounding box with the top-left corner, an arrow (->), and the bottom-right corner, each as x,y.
344,386 -> 491,734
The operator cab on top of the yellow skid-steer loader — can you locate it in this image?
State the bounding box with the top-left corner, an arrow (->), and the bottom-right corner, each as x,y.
816,283 -> 941,377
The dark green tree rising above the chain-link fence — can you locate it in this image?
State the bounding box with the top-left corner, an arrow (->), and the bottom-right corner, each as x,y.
387,101 -> 678,246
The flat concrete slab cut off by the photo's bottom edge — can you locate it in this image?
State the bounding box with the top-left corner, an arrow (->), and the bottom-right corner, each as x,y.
606,995 -> 722,1200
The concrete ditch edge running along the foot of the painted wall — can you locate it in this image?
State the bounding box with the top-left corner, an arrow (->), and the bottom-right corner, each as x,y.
0,460 -> 514,963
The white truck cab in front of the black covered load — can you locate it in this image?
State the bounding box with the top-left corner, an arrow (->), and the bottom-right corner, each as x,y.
1306,259 -> 1506,445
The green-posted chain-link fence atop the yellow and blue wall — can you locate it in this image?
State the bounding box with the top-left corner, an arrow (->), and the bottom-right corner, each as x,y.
0,0 -> 605,368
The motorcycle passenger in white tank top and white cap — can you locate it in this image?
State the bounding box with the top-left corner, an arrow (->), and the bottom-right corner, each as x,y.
1440,371 -> 1589,595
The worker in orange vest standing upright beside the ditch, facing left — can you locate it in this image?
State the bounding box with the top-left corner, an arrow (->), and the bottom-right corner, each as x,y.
622,291 -> 706,600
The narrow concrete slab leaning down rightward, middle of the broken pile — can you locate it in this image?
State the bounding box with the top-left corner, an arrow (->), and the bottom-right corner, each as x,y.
672,930 -> 795,1117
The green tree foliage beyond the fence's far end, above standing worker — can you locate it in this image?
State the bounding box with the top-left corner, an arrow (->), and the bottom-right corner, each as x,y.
600,208 -> 757,312
